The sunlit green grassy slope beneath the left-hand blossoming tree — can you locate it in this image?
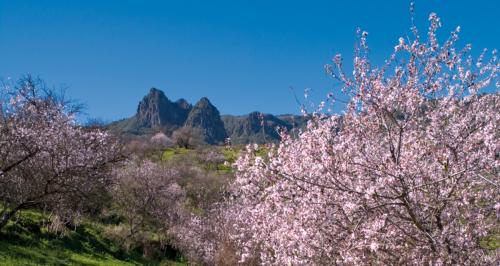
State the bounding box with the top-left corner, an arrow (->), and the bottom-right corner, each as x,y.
0,211 -> 186,266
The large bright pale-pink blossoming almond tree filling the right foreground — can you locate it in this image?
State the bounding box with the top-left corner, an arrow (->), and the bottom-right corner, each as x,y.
226,9 -> 500,265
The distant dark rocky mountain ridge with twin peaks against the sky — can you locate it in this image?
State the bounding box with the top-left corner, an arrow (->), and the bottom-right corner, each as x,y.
107,88 -> 307,144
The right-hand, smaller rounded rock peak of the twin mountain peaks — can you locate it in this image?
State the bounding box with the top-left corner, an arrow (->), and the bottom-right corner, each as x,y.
184,97 -> 226,144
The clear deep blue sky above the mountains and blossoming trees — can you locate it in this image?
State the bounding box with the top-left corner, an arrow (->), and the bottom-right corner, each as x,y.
0,0 -> 500,120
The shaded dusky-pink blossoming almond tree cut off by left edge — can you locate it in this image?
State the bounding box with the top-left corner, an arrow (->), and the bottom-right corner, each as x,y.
0,77 -> 119,228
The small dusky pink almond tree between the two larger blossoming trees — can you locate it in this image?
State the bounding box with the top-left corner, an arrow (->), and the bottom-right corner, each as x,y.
111,160 -> 186,252
